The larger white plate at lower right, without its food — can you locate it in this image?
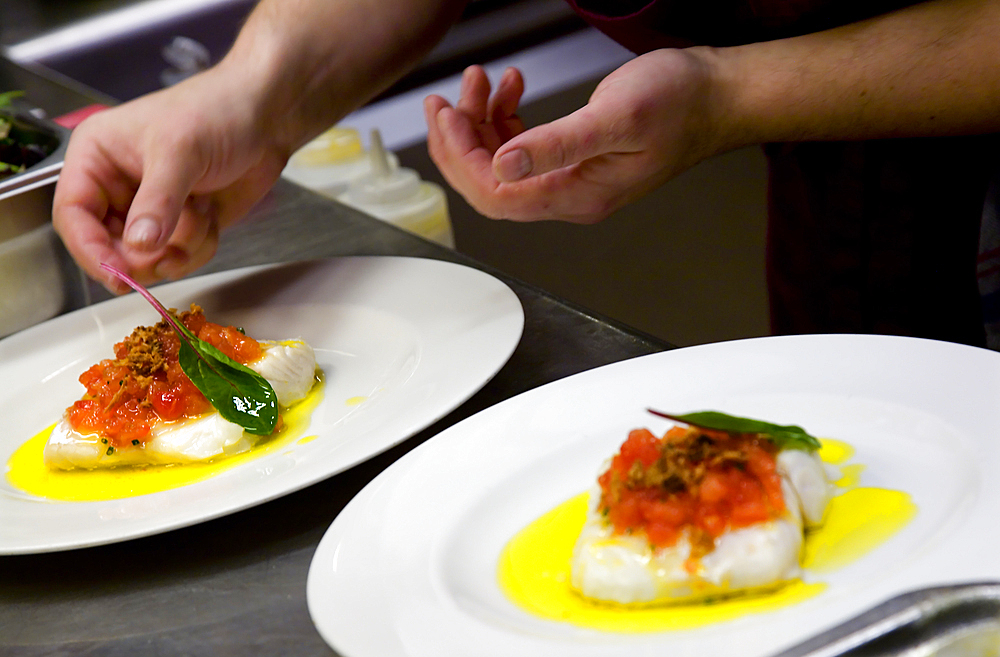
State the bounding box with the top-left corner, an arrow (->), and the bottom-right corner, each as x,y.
307,335 -> 1000,657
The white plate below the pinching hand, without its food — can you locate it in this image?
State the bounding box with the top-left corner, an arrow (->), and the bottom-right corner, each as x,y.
0,257 -> 524,554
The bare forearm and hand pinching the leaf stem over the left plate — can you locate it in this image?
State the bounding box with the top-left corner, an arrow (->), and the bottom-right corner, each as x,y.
53,0 -> 464,291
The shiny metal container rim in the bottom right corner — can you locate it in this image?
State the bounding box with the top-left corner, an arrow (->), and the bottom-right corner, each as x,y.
774,582 -> 1000,657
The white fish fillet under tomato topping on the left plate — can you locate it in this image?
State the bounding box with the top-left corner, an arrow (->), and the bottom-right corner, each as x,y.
43,340 -> 316,470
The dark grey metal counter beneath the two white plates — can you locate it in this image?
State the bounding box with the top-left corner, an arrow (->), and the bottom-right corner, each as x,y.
0,177 -> 670,657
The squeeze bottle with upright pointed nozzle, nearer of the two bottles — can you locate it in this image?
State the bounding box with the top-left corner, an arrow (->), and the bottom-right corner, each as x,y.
337,129 -> 455,248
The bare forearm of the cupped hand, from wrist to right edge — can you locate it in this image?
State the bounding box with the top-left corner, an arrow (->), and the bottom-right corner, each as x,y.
698,0 -> 1000,151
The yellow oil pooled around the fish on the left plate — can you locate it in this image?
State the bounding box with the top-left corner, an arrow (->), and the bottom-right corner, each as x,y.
7,376 -> 324,502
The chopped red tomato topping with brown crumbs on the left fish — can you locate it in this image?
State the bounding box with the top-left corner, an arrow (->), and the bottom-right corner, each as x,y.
67,304 -> 263,448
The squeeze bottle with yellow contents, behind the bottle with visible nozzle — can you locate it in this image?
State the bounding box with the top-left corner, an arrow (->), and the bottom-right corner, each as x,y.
281,126 -> 399,198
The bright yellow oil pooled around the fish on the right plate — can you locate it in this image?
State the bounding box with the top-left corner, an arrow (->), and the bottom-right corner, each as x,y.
497,440 -> 916,633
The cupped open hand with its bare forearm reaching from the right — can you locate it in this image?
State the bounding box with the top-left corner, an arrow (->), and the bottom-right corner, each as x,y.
426,0 -> 1000,223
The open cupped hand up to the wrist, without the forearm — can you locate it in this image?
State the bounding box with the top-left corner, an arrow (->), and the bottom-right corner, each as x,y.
424,50 -> 715,223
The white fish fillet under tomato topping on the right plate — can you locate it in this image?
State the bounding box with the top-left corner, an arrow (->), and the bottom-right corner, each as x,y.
571,450 -> 832,604
